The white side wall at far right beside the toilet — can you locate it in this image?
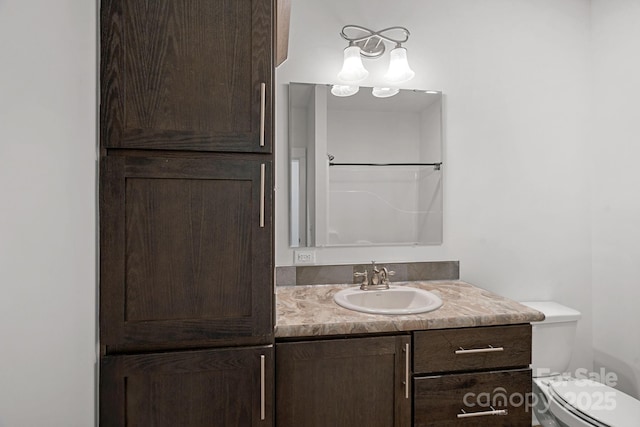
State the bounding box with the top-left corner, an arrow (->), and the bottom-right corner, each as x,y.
590,0 -> 640,398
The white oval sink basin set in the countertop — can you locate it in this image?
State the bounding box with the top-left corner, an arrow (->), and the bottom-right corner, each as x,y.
333,286 -> 442,314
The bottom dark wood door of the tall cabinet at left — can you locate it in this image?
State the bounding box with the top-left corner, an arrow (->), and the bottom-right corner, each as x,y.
100,346 -> 273,427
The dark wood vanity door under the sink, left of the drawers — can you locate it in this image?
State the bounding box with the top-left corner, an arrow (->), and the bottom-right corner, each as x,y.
276,335 -> 411,427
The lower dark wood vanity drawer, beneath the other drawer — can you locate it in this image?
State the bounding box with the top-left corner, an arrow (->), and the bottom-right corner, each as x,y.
413,368 -> 531,427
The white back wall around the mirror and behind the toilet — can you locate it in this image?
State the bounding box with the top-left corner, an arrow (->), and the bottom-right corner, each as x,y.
276,0 -> 592,367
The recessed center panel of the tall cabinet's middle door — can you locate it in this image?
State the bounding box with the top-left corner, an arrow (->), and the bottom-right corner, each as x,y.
125,178 -> 255,322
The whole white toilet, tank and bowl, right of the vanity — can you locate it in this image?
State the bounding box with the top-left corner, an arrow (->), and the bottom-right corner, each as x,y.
521,301 -> 640,427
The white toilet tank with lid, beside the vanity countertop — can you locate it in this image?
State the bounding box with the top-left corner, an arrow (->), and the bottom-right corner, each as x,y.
521,301 -> 581,377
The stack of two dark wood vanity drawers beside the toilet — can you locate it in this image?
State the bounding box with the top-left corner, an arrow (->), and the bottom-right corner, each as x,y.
413,324 -> 531,427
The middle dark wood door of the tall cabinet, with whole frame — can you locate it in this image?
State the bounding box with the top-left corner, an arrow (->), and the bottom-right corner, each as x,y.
100,155 -> 273,353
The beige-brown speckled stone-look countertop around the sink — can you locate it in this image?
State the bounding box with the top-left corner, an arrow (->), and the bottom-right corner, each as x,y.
275,281 -> 544,338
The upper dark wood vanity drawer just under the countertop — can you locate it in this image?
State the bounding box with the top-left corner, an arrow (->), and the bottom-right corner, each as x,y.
413,324 -> 531,374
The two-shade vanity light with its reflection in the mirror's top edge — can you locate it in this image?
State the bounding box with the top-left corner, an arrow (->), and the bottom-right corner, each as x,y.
331,25 -> 415,98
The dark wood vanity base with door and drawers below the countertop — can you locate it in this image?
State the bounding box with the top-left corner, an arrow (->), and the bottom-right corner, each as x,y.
275,324 -> 531,427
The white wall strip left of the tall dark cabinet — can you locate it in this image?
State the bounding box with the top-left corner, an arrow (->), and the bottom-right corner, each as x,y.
0,0 -> 96,427
